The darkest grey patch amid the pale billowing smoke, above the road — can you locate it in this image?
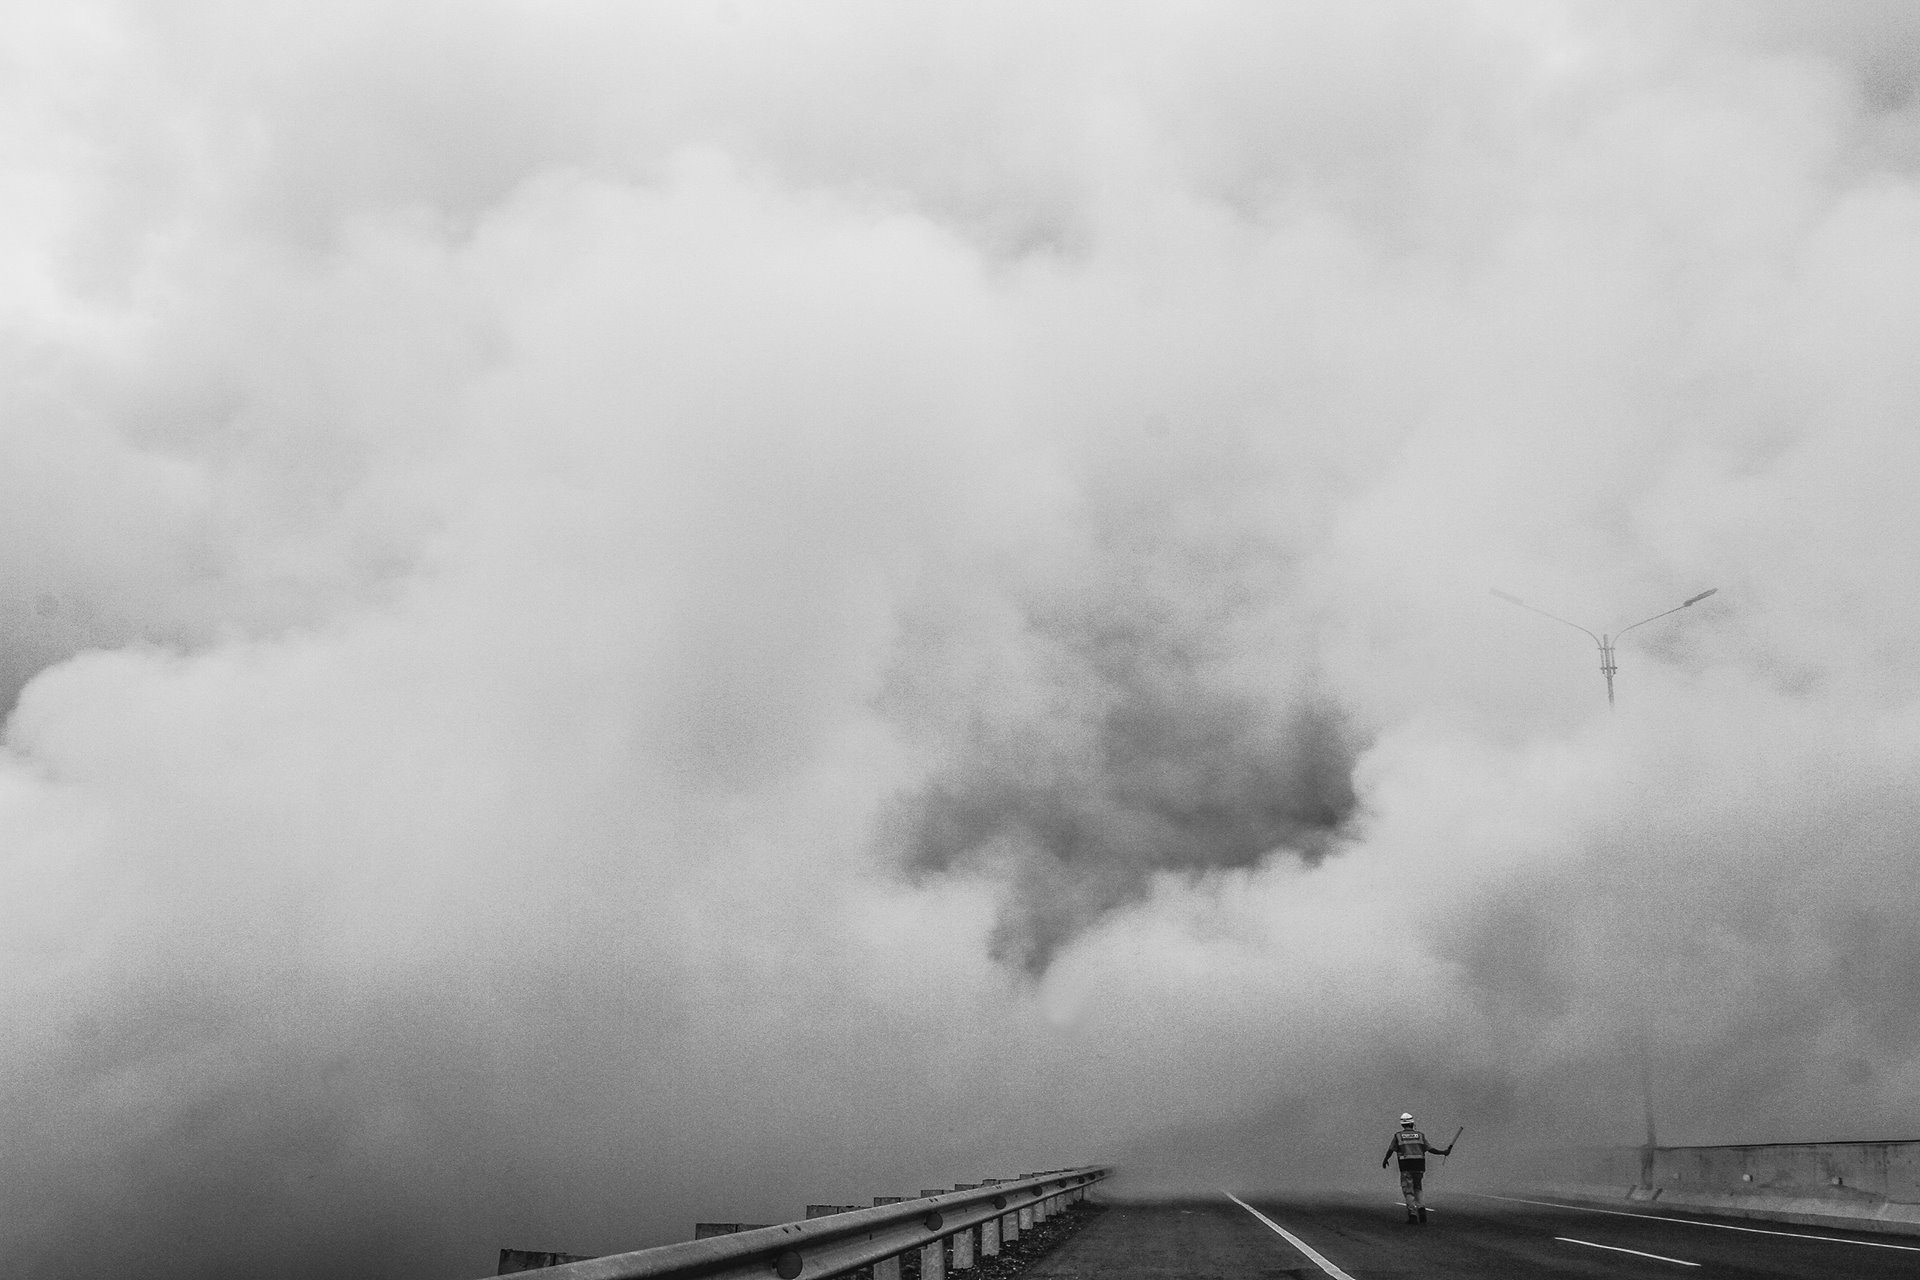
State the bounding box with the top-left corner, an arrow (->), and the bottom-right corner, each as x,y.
895,687 -> 1356,975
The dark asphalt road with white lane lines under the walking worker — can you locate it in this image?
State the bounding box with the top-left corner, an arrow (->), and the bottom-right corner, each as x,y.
1027,1192 -> 1920,1280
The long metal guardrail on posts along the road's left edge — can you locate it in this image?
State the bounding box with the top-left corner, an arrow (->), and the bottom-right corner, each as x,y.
480,1165 -> 1112,1280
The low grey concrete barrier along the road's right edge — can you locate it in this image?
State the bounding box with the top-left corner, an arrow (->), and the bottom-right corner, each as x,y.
1544,1140 -> 1920,1234
